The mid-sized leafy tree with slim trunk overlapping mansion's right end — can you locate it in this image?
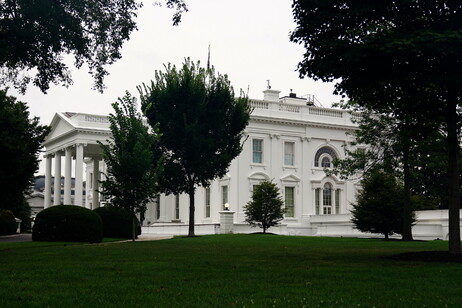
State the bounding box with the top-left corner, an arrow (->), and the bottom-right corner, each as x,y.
330,106 -> 438,241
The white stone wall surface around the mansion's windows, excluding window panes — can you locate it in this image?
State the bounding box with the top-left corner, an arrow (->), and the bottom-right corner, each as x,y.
147,90 -> 356,226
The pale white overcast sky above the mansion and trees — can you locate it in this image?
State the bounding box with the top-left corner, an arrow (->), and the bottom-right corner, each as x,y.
9,0 -> 340,124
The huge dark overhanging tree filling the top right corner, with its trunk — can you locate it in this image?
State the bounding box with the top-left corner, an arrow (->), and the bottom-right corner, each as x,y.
291,0 -> 462,253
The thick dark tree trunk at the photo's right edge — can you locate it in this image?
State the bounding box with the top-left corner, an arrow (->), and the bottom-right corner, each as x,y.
446,93 -> 461,254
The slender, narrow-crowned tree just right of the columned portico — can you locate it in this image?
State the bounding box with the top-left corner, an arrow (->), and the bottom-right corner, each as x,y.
100,92 -> 162,240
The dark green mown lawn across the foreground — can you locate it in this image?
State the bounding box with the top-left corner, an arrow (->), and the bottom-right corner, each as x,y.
0,235 -> 462,308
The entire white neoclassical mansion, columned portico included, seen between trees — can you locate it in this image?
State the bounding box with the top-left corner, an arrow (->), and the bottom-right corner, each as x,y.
44,89 -> 458,238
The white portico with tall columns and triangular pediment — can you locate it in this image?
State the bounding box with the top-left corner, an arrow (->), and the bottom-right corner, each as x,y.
44,112 -> 111,209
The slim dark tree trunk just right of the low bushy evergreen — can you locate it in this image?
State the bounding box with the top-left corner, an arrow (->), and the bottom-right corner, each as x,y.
402,137 -> 413,241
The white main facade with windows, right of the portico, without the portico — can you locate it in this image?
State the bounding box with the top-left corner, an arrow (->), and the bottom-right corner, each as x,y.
145,89 -> 356,226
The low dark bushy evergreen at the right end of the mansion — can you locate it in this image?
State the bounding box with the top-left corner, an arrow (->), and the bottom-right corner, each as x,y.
351,170 -> 414,239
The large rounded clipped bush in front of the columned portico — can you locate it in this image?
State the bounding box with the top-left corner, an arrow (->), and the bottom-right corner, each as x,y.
32,205 -> 103,243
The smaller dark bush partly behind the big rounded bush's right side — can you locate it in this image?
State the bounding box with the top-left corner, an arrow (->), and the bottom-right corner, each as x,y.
93,206 -> 141,238
